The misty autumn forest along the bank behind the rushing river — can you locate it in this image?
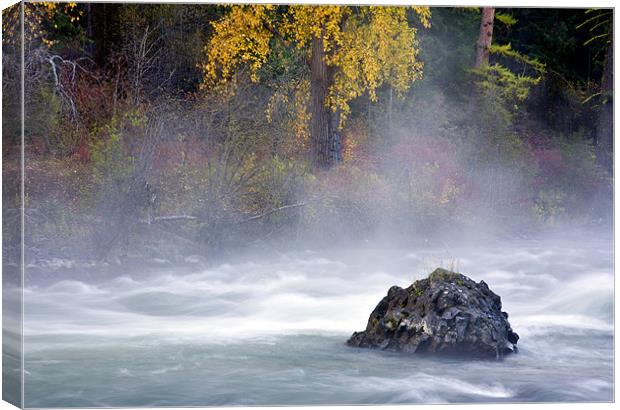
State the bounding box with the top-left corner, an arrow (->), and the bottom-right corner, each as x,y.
2,3 -> 613,266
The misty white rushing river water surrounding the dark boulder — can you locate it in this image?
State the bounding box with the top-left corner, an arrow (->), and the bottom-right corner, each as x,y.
17,235 -> 613,407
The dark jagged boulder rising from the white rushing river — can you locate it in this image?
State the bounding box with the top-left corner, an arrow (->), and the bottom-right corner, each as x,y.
347,269 -> 519,358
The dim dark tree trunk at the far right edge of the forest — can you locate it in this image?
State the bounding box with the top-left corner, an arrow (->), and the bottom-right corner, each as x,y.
596,31 -> 614,175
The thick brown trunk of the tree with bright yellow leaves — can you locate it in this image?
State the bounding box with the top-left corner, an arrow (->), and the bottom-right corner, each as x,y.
310,37 -> 341,169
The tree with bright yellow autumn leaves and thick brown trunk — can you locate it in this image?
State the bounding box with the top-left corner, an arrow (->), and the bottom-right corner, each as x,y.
203,5 -> 430,168
